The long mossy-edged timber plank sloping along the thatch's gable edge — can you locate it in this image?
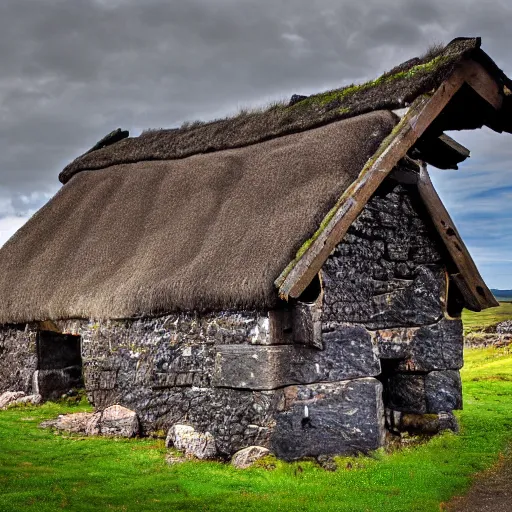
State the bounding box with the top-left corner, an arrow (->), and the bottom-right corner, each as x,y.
276,68 -> 465,299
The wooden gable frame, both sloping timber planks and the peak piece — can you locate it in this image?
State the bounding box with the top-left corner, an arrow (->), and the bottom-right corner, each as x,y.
275,60 -> 503,311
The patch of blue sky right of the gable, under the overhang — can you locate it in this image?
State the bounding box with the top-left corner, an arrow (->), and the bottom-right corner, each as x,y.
430,129 -> 512,289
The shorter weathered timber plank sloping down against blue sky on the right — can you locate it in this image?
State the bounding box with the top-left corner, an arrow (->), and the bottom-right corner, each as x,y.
418,165 -> 499,311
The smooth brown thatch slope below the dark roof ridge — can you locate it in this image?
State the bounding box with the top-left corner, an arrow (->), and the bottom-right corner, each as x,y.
0,111 -> 397,324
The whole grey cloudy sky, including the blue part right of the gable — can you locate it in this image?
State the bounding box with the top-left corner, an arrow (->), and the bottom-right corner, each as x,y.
0,0 -> 512,288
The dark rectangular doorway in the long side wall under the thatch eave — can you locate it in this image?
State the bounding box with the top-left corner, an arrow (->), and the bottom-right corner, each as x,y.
33,331 -> 83,400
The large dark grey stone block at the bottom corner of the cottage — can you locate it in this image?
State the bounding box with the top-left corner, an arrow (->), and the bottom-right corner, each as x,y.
270,378 -> 384,461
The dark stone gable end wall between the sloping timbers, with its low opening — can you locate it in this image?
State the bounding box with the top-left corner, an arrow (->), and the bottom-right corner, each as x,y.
322,182 -> 463,414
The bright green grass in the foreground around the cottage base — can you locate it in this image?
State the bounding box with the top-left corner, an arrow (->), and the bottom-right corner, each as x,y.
0,349 -> 512,512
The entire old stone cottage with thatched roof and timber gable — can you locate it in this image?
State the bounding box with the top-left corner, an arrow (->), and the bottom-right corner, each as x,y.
0,38 -> 512,460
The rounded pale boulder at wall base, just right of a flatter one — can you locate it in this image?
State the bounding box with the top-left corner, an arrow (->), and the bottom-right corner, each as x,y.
86,405 -> 140,437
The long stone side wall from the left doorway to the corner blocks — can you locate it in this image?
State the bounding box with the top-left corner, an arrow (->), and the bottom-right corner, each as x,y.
61,312 -> 384,459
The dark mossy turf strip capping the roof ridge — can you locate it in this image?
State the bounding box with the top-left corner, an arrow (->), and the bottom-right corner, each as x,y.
59,38 -> 504,183
